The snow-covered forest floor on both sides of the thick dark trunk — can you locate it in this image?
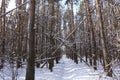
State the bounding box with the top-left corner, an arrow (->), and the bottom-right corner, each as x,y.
0,55 -> 113,80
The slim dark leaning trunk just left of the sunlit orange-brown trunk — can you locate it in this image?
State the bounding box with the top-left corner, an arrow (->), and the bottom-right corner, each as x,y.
86,0 -> 97,70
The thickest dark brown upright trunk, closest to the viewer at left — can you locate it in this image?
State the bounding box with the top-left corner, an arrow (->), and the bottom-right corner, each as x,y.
26,0 -> 35,80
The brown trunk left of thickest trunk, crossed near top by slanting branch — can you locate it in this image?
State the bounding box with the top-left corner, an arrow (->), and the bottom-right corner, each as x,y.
16,0 -> 22,68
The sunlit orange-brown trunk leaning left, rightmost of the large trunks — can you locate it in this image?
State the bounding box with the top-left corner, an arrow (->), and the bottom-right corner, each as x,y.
96,0 -> 112,76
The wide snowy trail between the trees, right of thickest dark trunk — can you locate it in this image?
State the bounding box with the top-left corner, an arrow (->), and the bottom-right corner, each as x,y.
35,55 -> 110,80
